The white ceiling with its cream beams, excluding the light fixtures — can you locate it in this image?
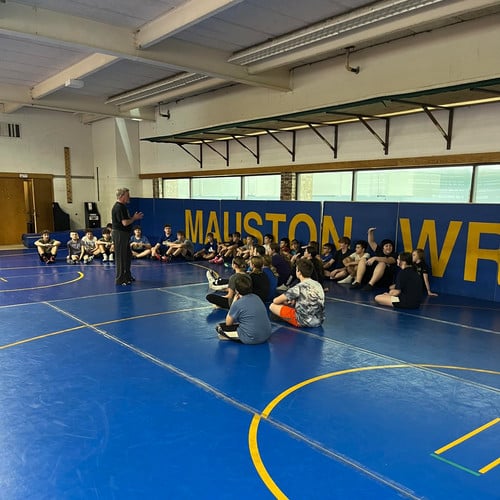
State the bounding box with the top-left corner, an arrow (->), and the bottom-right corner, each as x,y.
0,0 -> 500,120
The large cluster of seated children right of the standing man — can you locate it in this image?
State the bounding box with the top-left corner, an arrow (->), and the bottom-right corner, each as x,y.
206,228 -> 436,344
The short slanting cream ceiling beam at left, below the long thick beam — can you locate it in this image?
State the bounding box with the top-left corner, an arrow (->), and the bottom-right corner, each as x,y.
31,53 -> 118,99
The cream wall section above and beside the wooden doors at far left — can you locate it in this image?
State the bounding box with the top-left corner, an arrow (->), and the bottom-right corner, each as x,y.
0,109 -> 96,228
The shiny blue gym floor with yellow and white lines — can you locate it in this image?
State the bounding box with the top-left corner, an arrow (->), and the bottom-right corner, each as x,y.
0,249 -> 500,500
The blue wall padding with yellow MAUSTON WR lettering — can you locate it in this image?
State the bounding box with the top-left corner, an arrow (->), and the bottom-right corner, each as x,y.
124,198 -> 500,302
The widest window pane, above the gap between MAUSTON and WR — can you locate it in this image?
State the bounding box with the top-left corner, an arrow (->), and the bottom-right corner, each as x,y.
354,166 -> 472,203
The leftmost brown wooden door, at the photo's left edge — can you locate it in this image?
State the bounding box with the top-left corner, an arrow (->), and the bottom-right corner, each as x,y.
0,177 -> 28,245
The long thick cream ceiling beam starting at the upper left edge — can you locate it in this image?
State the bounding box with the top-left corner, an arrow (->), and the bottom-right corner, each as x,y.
0,3 -> 290,91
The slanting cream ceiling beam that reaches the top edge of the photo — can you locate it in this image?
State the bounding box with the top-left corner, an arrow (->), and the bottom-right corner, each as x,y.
135,0 -> 243,49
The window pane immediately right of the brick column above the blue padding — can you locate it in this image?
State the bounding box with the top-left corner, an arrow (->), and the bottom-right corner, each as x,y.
297,172 -> 353,201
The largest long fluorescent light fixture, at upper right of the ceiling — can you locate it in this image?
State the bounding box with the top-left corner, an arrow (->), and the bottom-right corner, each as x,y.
228,0 -> 444,65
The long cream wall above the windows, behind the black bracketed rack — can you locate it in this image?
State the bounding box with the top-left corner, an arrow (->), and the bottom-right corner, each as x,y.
140,15 -> 500,178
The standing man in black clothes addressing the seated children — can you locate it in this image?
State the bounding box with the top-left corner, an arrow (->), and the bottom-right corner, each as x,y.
111,188 -> 144,285
